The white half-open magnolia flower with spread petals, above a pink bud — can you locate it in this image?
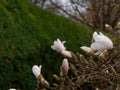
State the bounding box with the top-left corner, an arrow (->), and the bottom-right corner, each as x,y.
51,39 -> 65,52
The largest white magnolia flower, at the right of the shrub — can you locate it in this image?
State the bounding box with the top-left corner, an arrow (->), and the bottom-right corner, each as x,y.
90,32 -> 113,55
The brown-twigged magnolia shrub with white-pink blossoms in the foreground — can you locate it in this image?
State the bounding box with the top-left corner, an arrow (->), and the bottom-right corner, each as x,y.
32,29 -> 120,90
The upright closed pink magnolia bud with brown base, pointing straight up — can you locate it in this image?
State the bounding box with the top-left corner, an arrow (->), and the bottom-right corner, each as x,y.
61,59 -> 69,76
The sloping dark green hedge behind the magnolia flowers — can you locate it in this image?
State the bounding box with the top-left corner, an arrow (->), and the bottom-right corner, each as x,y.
0,0 -> 93,90
